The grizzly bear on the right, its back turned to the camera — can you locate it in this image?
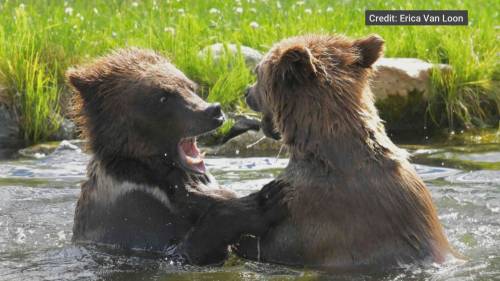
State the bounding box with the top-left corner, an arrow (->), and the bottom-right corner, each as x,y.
184,35 -> 454,270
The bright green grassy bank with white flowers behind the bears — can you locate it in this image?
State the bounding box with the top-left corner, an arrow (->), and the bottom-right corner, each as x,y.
0,0 -> 500,142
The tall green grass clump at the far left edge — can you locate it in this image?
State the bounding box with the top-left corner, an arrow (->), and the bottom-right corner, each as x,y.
0,6 -> 61,143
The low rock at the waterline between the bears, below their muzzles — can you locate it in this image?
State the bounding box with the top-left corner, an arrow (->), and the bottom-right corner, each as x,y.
205,131 -> 281,156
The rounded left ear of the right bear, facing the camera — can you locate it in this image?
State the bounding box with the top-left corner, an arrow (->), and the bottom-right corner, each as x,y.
275,46 -> 317,85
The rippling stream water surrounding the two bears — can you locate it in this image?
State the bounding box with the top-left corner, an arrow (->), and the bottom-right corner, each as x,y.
0,145 -> 500,280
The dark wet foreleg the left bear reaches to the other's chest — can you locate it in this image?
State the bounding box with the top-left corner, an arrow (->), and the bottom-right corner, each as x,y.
179,181 -> 288,265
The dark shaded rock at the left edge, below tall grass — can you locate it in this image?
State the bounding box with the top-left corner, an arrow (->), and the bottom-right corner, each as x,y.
0,104 -> 24,158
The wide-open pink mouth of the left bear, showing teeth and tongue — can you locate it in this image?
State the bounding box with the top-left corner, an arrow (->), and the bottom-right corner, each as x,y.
178,137 -> 206,174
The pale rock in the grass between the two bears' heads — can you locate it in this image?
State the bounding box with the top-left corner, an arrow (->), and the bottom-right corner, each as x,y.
198,43 -> 262,69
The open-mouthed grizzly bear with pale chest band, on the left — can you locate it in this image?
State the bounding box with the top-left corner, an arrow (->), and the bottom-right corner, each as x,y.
67,48 -> 282,263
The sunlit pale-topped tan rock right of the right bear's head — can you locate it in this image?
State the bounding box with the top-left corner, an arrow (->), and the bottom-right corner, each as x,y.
370,58 -> 451,100
